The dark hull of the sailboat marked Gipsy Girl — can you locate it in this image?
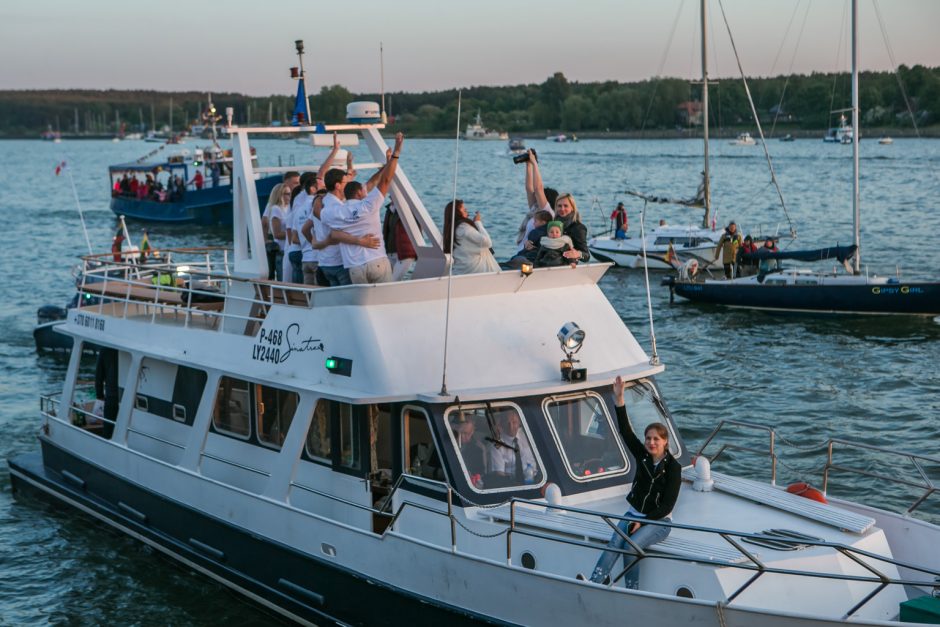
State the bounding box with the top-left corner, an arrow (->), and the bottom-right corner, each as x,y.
671,281 -> 940,316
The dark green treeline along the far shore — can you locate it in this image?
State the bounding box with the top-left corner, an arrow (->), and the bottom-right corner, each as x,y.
0,65 -> 940,137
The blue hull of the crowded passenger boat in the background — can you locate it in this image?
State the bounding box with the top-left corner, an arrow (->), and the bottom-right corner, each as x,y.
111,175 -> 282,225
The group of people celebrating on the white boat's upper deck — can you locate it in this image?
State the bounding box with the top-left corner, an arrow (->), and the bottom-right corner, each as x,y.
261,142 -> 590,286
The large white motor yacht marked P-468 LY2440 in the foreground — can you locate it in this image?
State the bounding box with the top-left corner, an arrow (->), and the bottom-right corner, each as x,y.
10,61 -> 940,627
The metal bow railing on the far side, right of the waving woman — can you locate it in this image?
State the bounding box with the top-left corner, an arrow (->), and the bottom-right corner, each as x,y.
695,420 -> 940,514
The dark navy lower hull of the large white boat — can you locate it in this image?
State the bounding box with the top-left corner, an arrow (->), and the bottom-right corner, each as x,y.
9,438 -> 507,626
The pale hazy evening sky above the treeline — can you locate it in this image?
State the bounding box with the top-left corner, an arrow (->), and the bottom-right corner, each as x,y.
0,0 -> 940,96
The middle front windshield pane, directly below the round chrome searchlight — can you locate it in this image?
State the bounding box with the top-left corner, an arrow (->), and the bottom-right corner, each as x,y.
544,394 -> 627,481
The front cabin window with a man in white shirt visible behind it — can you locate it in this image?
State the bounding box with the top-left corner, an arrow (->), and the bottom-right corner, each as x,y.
445,403 -> 545,491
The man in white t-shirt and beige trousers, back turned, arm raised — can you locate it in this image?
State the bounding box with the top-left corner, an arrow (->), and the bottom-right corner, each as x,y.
318,133 -> 404,284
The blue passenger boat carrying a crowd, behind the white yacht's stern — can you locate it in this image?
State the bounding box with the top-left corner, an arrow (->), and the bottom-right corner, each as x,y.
108,145 -> 282,225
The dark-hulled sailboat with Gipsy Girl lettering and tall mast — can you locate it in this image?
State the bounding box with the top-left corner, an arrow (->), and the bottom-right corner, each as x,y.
664,0 -> 940,316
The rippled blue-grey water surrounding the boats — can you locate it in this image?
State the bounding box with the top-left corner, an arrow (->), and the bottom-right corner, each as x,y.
0,139 -> 940,625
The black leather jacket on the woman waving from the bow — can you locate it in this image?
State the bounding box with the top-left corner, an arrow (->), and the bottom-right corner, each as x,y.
615,406 -> 682,520
